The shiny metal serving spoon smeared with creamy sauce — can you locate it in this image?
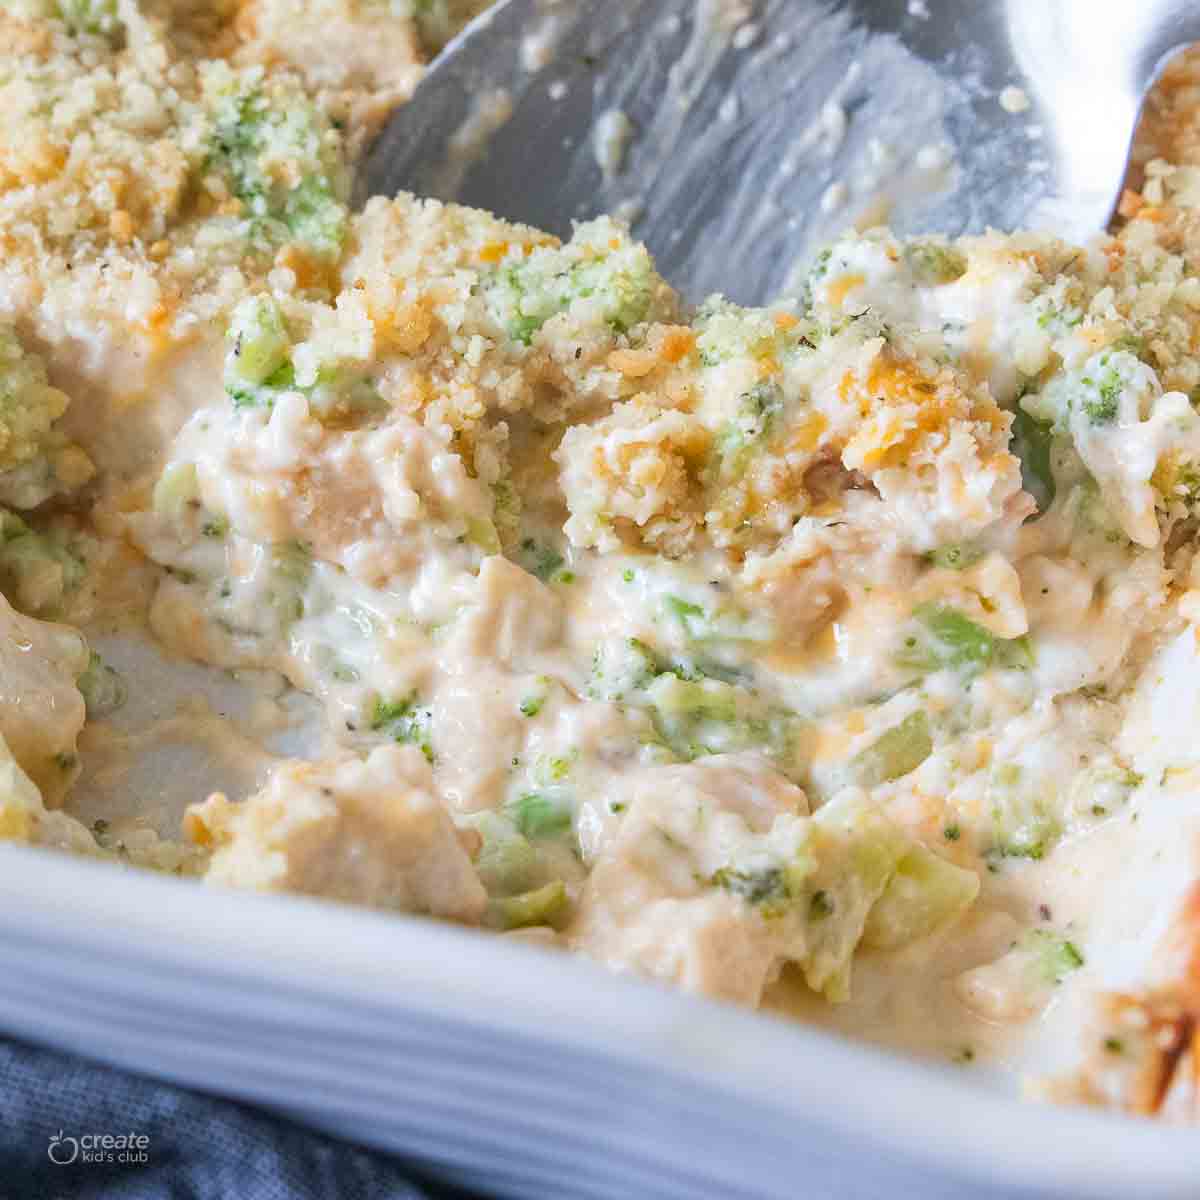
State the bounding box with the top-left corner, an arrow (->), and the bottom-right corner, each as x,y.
360,0 -> 1200,302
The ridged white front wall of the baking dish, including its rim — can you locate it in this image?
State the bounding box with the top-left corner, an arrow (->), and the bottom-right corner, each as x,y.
0,846 -> 1200,1200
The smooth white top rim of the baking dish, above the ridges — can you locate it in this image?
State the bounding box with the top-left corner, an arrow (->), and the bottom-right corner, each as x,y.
0,845 -> 1200,1196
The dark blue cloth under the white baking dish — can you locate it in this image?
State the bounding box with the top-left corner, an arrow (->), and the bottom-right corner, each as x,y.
0,1038 -> 482,1200
